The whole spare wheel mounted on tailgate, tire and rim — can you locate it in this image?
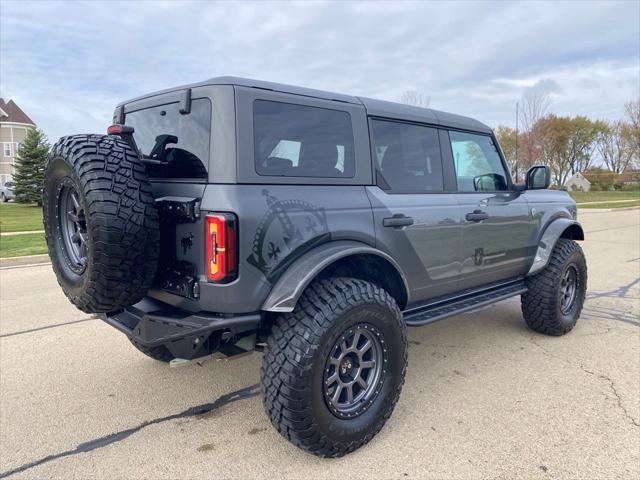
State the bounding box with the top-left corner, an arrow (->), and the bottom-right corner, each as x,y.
43,135 -> 160,313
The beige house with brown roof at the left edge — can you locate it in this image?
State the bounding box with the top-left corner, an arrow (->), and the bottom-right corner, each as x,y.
0,98 -> 36,186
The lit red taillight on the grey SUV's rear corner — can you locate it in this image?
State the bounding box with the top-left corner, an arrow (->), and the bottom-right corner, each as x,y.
205,213 -> 237,283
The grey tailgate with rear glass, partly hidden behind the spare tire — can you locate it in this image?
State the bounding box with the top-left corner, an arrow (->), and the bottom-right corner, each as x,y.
124,88 -> 217,304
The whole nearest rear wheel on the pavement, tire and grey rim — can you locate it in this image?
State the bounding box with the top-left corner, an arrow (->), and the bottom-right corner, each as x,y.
261,278 -> 407,457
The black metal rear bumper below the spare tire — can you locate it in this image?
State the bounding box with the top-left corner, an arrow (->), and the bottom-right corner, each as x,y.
102,298 -> 261,359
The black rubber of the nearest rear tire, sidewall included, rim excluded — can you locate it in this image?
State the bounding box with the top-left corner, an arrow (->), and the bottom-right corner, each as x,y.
261,278 -> 407,457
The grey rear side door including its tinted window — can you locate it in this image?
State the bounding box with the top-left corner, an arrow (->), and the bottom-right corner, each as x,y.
367,118 -> 462,304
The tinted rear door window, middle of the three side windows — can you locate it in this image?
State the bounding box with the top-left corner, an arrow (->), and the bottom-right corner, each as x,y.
371,120 -> 443,193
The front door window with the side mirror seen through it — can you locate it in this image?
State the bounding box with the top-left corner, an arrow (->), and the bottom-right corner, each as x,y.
449,131 -> 509,192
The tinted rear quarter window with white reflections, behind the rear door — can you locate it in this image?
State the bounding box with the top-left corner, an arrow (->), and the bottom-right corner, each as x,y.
253,100 -> 355,178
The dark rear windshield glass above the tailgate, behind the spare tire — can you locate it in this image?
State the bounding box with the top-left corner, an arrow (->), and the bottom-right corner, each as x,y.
125,98 -> 211,178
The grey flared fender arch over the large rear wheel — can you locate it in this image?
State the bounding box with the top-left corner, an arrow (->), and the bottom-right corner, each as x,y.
261,240 -> 409,312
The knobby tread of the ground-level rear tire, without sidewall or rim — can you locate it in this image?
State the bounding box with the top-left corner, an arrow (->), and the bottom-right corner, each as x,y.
261,277 -> 407,457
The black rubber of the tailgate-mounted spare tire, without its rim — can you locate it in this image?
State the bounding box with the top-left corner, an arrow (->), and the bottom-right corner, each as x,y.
43,135 -> 160,313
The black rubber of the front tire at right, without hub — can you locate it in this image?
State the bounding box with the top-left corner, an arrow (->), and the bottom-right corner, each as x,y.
521,238 -> 587,336
